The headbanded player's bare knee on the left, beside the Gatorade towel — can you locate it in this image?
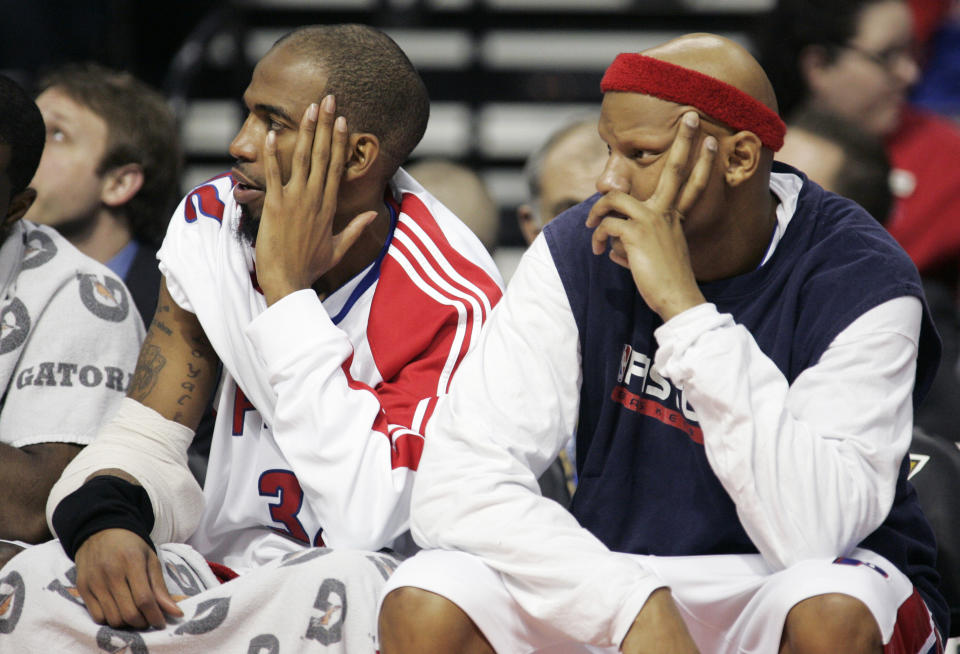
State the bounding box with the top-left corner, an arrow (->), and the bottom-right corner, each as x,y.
380,586 -> 493,654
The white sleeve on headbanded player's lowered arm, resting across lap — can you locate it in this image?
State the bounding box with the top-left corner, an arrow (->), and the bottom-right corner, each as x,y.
411,236 -> 664,646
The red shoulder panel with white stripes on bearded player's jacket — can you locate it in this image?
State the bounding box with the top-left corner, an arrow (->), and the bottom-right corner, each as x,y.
367,193 -> 502,470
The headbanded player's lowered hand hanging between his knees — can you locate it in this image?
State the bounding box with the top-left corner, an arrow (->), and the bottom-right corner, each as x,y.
620,588 -> 699,654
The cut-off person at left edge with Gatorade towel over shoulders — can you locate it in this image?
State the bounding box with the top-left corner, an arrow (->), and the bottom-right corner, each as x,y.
0,76 -> 143,567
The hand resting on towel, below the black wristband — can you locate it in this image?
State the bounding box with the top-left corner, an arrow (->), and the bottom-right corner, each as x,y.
75,529 -> 183,629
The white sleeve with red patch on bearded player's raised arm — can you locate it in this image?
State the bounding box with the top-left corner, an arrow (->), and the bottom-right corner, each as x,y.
246,289 -> 453,550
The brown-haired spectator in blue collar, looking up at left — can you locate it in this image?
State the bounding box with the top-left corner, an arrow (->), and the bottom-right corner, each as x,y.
27,64 -> 180,325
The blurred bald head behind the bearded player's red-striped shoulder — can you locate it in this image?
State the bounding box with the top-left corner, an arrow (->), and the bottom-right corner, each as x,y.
404,159 -> 500,252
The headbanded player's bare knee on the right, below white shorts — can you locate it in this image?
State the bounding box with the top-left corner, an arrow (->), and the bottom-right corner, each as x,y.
780,593 -> 883,654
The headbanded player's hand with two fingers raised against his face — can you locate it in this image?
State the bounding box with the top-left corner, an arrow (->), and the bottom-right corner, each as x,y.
587,111 -> 717,321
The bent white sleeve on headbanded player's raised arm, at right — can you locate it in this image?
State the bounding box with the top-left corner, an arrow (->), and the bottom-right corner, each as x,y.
655,297 -> 922,568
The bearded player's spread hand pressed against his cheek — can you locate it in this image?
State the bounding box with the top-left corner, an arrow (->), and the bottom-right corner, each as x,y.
256,95 -> 377,304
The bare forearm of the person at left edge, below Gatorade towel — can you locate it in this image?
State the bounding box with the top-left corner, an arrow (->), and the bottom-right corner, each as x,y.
0,443 -> 81,543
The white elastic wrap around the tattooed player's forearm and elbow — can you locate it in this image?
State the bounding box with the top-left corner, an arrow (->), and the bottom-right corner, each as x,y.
47,398 -> 203,545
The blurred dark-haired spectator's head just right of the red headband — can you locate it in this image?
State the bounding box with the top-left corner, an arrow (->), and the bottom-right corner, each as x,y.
776,108 -> 893,223
